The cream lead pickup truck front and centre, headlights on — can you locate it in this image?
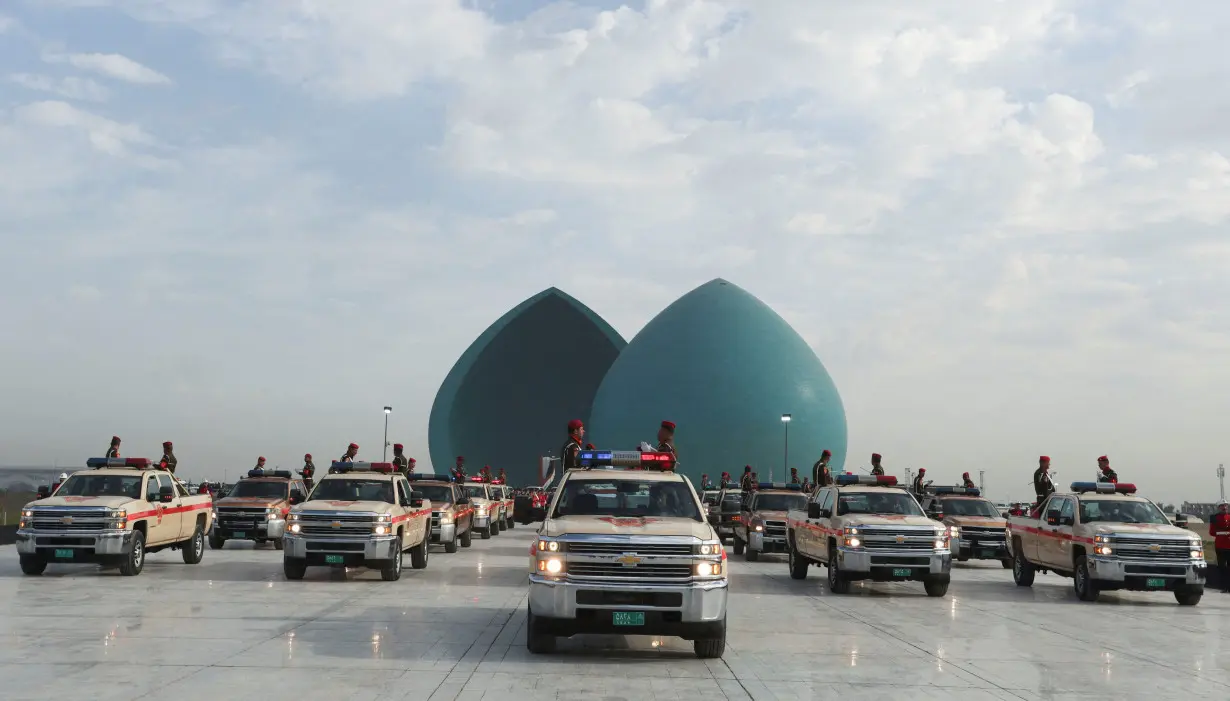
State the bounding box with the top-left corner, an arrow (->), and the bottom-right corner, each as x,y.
525,450 -> 727,658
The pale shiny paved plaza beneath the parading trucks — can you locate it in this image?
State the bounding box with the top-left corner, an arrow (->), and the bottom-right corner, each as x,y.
0,526 -> 1230,701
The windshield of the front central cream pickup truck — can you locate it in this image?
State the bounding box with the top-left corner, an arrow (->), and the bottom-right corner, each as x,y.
554,480 -> 704,521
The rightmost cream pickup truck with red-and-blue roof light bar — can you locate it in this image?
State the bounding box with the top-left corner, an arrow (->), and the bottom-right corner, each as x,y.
1007,482 -> 1205,606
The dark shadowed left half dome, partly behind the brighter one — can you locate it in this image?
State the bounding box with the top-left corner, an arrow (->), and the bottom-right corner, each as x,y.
428,288 -> 626,485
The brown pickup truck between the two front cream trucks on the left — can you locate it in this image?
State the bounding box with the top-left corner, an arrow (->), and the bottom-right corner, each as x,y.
209,470 -> 306,550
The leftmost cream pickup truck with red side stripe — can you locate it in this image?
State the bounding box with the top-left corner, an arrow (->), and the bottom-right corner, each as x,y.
17,457 -> 213,577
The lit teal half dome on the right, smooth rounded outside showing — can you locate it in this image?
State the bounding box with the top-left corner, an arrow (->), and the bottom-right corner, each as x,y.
587,279 -> 846,483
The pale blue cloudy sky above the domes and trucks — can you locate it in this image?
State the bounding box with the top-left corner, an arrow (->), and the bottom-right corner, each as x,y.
0,0 -> 1230,501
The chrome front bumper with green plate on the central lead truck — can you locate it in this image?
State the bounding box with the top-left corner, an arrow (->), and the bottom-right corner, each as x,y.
529,574 -> 727,640
